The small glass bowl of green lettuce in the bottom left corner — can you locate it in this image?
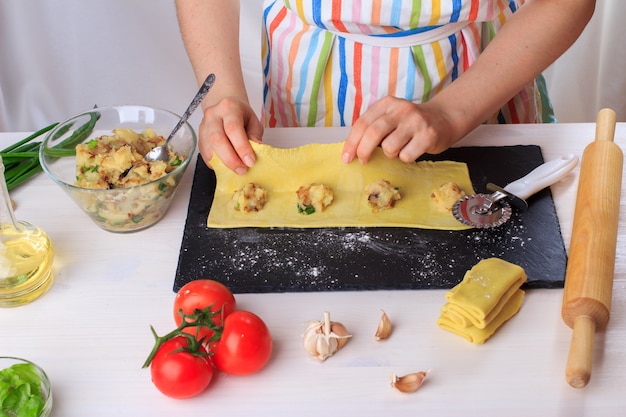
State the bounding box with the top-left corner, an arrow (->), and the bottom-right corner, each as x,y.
0,356 -> 52,417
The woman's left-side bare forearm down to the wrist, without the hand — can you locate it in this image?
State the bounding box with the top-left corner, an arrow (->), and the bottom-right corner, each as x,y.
176,0 -> 248,107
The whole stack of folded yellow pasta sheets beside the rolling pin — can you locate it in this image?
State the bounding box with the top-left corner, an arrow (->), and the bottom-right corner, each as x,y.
437,258 -> 526,344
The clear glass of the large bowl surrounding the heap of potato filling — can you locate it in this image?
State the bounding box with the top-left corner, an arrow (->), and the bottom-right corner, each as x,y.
39,105 -> 198,233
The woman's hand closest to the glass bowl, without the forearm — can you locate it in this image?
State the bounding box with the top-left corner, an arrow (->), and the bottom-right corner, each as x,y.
199,97 -> 263,175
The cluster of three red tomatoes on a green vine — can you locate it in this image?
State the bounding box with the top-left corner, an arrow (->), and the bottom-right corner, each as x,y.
143,279 -> 272,398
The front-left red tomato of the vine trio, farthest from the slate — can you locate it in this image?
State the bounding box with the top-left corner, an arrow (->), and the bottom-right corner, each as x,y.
150,336 -> 213,399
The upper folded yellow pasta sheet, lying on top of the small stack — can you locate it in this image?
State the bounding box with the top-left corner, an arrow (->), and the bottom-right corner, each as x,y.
443,258 -> 526,329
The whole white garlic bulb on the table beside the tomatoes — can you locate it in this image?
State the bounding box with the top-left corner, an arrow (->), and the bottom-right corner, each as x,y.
302,312 -> 352,361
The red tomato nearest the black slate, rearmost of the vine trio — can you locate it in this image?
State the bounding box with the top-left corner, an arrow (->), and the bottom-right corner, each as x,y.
174,279 -> 237,340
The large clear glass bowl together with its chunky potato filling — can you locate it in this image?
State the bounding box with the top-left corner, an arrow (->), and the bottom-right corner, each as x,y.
39,105 -> 197,232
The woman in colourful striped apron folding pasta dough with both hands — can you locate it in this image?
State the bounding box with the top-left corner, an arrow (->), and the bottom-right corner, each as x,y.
176,0 -> 595,174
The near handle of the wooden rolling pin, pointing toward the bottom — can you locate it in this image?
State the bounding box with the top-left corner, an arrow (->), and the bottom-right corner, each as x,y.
565,316 -> 596,388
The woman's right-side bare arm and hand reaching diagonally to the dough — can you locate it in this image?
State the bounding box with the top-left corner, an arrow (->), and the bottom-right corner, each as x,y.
342,0 -> 596,163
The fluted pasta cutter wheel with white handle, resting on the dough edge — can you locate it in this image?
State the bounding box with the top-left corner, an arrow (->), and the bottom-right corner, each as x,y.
452,154 -> 578,229
